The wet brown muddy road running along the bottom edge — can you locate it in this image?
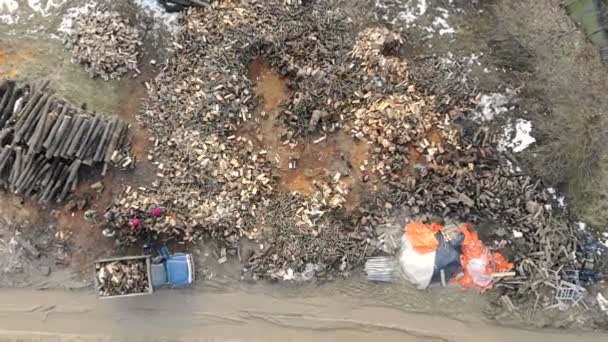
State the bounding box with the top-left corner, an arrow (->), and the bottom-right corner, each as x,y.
0,289 -> 605,342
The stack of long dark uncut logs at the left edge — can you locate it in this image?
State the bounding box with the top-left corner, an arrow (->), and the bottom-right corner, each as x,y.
0,81 -> 127,203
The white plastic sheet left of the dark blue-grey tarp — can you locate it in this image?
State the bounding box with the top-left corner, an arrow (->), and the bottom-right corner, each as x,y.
399,236 -> 436,290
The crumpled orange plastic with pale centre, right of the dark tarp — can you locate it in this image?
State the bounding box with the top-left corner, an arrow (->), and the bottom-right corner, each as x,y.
452,224 -> 513,291
